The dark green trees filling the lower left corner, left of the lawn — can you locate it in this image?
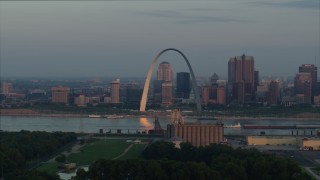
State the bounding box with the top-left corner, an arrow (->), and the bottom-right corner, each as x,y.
0,130 -> 77,179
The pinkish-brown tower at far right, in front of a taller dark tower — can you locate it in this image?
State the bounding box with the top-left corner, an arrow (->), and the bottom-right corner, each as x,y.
294,73 -> 313,104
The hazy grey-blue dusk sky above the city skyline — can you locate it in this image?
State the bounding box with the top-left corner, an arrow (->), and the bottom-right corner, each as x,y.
0,0 -> 320,77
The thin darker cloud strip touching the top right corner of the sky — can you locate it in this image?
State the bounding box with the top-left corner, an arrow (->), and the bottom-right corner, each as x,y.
251,0 -> 319,9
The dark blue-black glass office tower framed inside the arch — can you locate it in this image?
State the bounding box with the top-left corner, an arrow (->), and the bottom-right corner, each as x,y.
176,72 -> 191,99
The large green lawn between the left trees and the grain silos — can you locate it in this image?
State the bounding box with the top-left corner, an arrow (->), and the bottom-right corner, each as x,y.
67,139 -> 130,165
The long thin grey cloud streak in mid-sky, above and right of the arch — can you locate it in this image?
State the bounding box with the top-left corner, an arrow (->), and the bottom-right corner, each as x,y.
135,8 -> 250,24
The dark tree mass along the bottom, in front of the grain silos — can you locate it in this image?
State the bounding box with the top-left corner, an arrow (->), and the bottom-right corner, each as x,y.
73,142 -> 311,180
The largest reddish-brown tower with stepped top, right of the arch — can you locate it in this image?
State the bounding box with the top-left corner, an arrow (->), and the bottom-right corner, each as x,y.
228,55 -> 255,104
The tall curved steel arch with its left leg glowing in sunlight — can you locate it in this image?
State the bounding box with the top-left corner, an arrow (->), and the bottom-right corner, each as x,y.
140,48 -> 201,112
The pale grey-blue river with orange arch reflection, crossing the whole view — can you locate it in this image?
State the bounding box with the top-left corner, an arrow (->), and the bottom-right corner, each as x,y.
0,116 -> 320,136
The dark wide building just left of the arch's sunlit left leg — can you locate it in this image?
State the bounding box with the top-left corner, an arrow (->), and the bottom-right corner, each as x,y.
126,84 -> 142,108
